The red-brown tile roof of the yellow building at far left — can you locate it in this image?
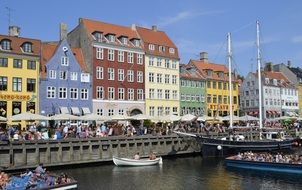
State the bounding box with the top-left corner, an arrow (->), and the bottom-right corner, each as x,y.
0,35 -> 41,56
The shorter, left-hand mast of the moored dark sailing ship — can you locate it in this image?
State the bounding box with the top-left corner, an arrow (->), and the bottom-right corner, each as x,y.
227,33 -> 233,128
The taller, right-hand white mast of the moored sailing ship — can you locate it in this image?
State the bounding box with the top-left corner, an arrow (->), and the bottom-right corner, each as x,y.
256,20 -> 263,129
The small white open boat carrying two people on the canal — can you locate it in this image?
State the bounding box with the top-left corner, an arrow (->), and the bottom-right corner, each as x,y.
113,157 -> 163,166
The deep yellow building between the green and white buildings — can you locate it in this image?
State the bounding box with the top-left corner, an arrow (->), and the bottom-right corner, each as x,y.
189,52 -> 239,117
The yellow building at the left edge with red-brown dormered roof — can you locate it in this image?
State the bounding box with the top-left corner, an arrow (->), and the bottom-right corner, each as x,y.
0,27 -> 41,128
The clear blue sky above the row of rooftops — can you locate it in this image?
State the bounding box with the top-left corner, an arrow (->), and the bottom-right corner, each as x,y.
0,0 -> 302,75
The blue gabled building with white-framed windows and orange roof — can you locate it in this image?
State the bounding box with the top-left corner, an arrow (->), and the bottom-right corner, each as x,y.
39,39 -> 92,115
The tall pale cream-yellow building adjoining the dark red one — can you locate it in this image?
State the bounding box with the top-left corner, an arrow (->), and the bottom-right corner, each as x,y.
136,26 -> 179,116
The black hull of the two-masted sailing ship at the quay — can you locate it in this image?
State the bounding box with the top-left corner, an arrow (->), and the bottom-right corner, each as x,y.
197,137 -> 294,157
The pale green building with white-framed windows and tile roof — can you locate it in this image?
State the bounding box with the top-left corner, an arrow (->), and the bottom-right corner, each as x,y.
180,65 -> 206,116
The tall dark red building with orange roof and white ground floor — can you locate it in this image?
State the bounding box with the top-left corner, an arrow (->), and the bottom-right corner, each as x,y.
68,19 -> 145,116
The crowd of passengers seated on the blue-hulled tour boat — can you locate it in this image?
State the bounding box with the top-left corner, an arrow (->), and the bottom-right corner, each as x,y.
235,151 -> 302,164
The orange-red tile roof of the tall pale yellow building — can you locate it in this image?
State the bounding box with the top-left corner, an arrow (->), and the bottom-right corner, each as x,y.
136,27 -> 179,59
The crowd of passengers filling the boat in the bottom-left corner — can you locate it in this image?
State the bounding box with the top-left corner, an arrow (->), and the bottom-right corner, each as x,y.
0,164 -> 72,189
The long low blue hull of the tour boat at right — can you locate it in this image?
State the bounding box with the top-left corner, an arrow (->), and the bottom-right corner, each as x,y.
225,156 -> 302,174
